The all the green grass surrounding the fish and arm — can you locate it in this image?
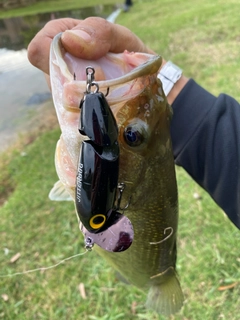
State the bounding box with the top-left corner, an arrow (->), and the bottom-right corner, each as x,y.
0,0 -> 240,320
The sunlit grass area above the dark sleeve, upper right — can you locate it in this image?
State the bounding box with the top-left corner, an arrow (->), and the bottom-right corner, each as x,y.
117,0 -> 240,99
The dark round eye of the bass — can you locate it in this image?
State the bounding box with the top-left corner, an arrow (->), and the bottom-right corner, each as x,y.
124,123 -> 146,147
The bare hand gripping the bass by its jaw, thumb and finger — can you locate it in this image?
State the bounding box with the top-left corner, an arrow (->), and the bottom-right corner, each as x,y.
28,17 -> 153,74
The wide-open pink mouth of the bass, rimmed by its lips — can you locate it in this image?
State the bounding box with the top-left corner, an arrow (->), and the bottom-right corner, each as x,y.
52,33 -> 162,83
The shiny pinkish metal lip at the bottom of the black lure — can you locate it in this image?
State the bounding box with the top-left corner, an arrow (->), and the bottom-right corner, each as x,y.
80,212 -> 134,252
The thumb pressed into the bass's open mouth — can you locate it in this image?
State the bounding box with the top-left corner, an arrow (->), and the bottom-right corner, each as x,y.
61,17 -> 153,59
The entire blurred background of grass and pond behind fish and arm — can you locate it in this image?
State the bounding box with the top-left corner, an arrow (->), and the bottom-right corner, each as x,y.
0,0 -> 240,320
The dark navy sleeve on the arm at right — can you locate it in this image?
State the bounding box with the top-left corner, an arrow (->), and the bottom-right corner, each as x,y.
171,80 -> 240,229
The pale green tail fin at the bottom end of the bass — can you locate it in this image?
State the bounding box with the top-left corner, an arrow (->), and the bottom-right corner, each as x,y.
146,267 -> 184,316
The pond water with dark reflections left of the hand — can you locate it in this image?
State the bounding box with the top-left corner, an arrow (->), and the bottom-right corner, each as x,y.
0,5 -> 120,151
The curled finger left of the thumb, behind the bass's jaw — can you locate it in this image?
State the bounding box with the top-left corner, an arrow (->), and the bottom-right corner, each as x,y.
28,18 -> 79,74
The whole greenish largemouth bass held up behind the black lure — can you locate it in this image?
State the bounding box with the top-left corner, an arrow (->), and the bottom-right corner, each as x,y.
50,31 -> 183,315
